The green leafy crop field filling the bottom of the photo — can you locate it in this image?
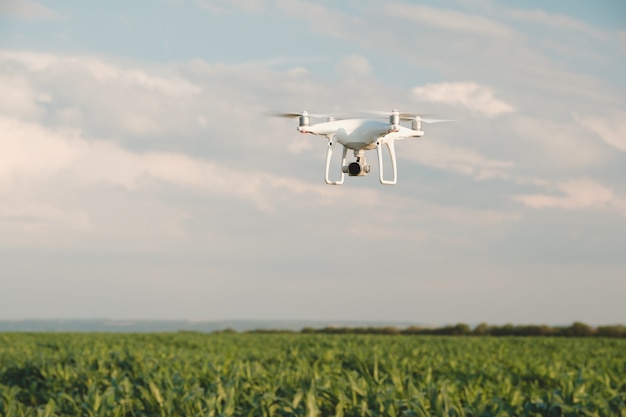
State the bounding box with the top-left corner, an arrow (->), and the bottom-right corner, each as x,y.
0,333 -> 626,417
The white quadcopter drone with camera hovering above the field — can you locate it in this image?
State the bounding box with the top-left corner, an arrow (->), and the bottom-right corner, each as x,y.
274,110 -> 449,185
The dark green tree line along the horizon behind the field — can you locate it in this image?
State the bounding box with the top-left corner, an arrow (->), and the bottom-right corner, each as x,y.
230,321 -> 626,338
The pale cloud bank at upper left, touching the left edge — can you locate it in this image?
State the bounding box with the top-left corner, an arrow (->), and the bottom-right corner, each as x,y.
0,51 -> 203,137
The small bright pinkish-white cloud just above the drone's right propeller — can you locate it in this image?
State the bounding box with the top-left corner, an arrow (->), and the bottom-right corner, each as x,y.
411,82 -> 515,117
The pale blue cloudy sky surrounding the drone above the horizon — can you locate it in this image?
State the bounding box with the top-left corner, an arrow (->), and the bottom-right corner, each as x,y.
0,0 -> 626,325
